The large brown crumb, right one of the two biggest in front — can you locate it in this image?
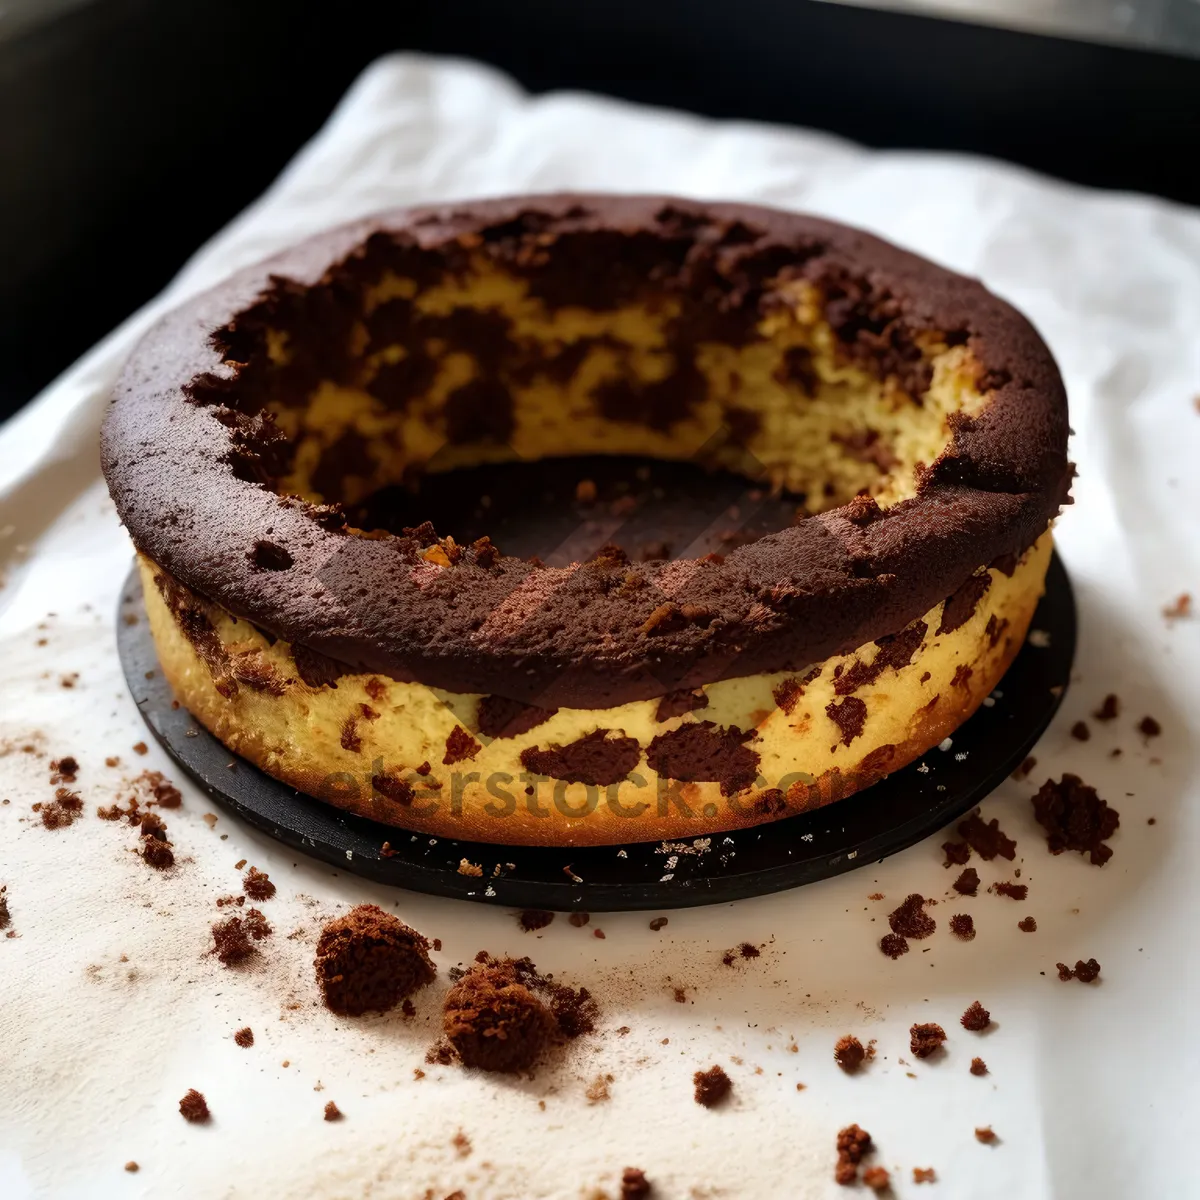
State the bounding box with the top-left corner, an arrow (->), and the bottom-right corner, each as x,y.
443,956 -> 554,1072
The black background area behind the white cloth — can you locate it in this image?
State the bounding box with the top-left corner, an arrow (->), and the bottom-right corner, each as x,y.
7,0 -> 1200,415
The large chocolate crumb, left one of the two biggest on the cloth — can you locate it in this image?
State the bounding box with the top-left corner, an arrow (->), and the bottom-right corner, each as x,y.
313,904 -> 437,1016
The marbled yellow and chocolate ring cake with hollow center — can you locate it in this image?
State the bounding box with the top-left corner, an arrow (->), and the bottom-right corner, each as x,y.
102,196 -> 1072,845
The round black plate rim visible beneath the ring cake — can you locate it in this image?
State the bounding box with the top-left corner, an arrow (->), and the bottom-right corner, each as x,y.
116,554 -> 1075,912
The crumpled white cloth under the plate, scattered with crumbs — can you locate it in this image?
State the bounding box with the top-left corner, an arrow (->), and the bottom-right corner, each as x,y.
0,55 -> 1200,1200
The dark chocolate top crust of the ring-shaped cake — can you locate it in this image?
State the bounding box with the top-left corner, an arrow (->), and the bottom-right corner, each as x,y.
101,194 -> 1072,708
